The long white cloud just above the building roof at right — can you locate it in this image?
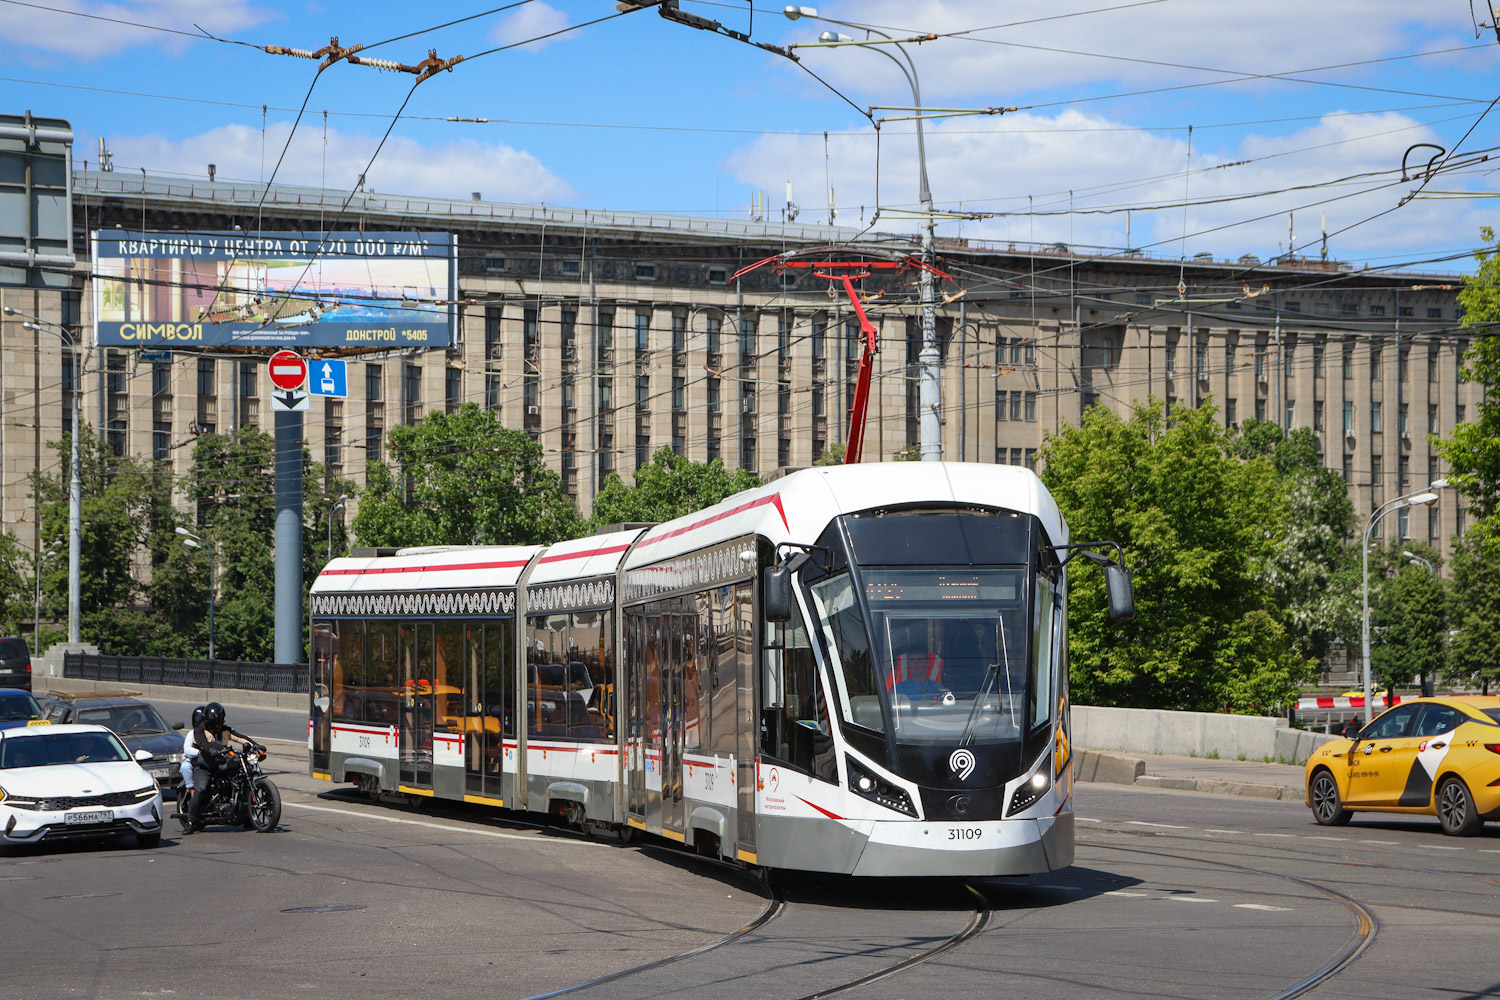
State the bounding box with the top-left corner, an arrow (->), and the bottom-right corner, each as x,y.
728,111 -> 1490,259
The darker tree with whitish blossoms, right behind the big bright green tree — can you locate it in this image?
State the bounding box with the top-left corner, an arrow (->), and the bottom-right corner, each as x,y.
1235,418 -> 1361,660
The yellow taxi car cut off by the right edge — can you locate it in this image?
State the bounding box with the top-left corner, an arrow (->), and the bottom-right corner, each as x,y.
1307,696 -> 1500,837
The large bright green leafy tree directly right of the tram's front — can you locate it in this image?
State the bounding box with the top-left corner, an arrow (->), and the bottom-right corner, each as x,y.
1041,399 -> 1313,712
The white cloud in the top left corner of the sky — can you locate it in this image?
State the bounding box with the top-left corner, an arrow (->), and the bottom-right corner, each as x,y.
0,0 -> 273,60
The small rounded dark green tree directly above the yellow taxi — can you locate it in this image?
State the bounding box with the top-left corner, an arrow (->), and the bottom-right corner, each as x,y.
1370,548 -> 1449,691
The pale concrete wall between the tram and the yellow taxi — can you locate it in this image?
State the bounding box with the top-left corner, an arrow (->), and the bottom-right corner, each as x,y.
1073,705 -> 1335,763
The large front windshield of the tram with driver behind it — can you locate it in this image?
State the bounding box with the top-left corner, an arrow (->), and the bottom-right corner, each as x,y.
809,567 -> 1052,744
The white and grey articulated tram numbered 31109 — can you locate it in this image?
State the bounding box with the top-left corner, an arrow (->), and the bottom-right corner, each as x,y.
308,463 -> 1134,877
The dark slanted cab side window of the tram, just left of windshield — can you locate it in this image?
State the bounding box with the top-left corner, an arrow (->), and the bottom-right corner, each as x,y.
761,619 -> 839,781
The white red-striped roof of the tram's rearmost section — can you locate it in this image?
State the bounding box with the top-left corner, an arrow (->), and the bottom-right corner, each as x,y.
312,546 -> 542,594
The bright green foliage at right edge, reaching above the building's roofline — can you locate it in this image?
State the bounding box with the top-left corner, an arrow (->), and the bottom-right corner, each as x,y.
1428,226 -> 1500,517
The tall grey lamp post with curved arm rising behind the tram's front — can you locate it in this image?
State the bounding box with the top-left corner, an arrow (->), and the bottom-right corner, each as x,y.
782,4 -> 942,462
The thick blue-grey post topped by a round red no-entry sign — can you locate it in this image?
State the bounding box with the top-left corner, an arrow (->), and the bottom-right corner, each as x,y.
269,351 -> 308,663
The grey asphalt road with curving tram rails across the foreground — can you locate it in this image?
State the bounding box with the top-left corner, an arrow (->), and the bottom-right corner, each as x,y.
0,754 -> 1500,1000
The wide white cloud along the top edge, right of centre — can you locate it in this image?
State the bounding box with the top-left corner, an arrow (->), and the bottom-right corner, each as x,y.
785,0 -> 1475,106
